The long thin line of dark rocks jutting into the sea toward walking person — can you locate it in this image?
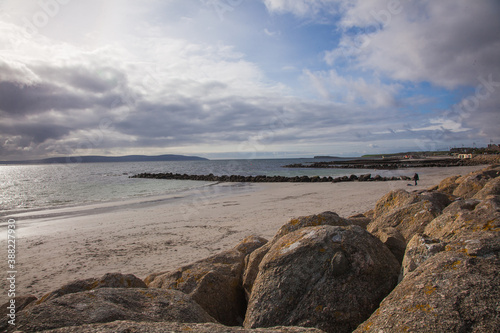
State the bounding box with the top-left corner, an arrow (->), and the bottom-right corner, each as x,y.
129,172 -> 411,183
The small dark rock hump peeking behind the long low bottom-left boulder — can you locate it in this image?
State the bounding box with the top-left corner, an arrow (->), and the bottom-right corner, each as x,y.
34,273 -> 147,304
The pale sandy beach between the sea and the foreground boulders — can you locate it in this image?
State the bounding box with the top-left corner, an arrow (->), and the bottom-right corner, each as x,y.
0,167 -> 482,304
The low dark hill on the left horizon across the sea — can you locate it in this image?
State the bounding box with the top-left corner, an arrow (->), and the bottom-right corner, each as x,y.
0,154 -> 208,164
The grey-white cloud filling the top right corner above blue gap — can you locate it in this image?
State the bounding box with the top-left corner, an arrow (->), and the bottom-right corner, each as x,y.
325,0 -> 500,89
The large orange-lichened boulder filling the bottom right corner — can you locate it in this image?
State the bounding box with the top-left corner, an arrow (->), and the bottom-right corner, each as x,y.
355,244 -> 500,333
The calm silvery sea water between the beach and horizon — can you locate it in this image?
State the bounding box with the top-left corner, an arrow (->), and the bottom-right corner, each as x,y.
0,159 -> 376,215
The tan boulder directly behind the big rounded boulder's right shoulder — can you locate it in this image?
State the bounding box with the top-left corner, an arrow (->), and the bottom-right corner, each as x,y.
367,190 -> 450,243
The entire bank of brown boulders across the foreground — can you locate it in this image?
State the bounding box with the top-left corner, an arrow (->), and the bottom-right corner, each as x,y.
0,166 -> 500,333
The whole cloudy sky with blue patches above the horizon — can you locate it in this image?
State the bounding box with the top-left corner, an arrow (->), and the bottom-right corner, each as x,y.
0,0 -> 500,160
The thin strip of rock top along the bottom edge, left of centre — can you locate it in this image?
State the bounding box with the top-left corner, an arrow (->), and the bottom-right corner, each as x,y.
43,321 -> 323,333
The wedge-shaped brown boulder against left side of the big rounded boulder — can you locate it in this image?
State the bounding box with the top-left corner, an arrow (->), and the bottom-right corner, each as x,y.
146,236 -> 267,326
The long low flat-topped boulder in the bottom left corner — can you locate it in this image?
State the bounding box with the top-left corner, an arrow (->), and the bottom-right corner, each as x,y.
0,288 -> 215,332
